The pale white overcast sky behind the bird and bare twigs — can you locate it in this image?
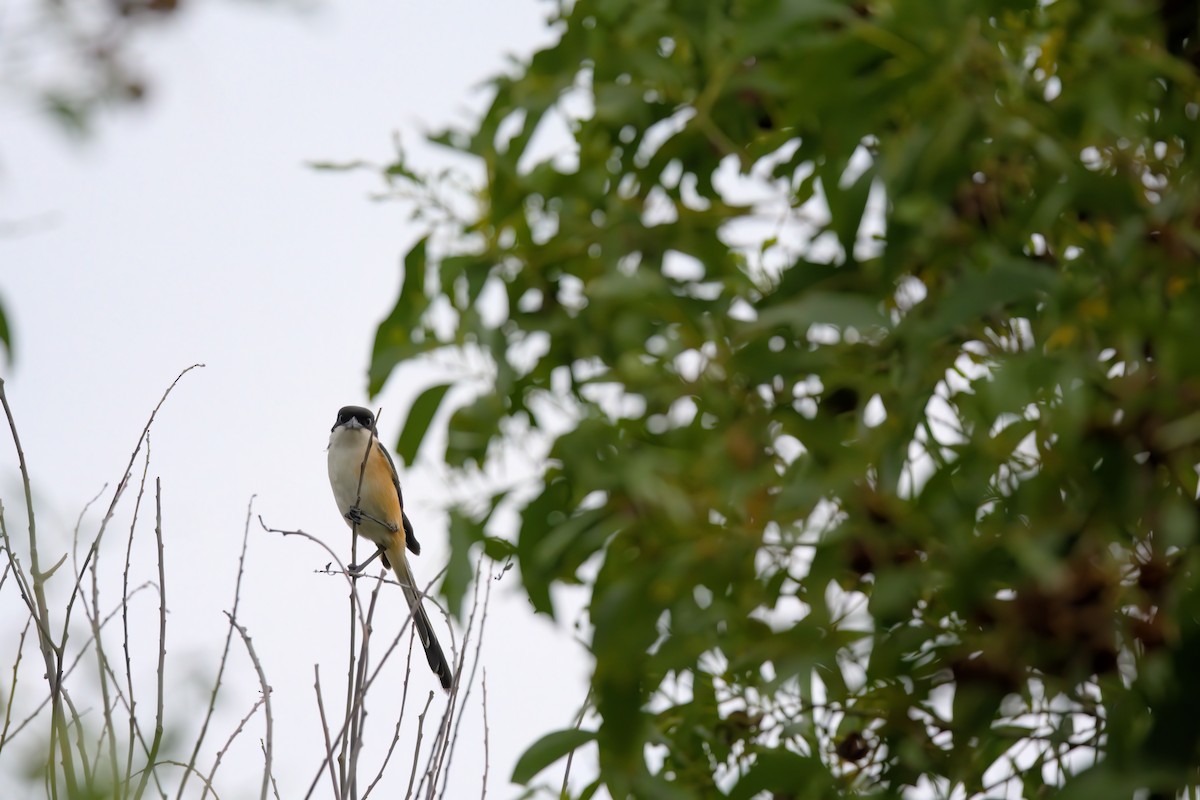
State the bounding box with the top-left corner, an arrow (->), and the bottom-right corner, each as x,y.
0,0 -> 587,798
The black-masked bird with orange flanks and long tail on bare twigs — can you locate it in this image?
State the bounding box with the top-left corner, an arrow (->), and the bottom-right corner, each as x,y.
329,405 -> 454,691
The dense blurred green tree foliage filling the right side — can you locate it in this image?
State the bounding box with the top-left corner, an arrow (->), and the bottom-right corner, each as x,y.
371,0 -> 1200,798
